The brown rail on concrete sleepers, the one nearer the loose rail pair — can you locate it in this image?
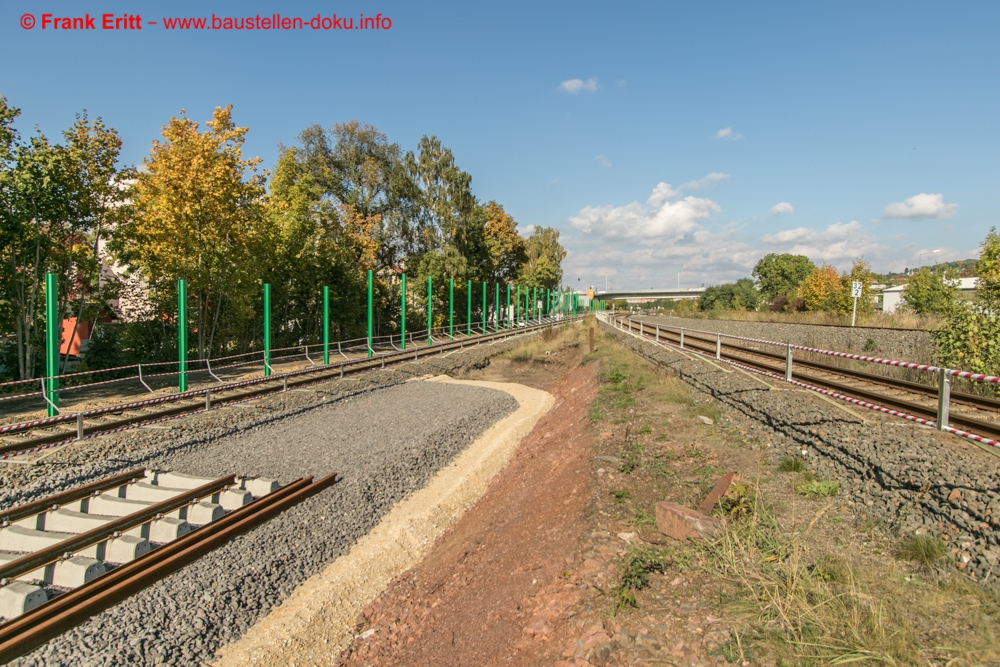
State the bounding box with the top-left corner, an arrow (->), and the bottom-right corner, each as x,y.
0,475 -> 236,585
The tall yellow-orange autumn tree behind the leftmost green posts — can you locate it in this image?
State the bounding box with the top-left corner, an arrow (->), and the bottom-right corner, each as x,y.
115,105 -> 275,358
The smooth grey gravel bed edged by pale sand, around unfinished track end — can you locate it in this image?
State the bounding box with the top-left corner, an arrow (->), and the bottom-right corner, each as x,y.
7,382 -> 517,666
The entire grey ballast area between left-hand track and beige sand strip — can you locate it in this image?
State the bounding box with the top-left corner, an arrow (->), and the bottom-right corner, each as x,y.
0,334 -> 552,665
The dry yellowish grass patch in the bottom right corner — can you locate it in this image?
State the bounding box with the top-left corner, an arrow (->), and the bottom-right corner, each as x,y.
702,470 -> 1000,667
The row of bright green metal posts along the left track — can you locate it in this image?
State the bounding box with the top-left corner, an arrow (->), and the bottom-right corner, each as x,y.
42,271 -> 584,417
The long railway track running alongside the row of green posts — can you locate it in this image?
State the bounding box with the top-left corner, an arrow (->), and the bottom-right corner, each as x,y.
0,318 -> 575,461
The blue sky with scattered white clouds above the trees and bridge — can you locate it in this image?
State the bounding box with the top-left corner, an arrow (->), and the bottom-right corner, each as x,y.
0,0 -> 1000,287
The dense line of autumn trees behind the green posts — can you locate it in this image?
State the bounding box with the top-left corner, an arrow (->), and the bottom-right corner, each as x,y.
0,95 -> 566,378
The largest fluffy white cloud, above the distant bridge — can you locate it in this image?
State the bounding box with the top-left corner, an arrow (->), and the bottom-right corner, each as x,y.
569,183 -> 722,240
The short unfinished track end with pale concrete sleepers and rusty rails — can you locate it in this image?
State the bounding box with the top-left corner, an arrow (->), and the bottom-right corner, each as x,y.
0,469 -> 337,663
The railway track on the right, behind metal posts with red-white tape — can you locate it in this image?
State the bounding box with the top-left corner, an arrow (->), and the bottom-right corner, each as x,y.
613,316 -> 1000,444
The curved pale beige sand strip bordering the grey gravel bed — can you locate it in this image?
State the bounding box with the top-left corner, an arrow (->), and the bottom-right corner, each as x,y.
215,378 -> 555,667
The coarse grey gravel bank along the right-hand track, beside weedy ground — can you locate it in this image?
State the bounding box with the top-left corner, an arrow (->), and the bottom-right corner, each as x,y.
601,323 -> 1000,582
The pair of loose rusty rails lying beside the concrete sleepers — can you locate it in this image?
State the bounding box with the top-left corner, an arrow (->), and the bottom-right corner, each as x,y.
0,473 -> 337,664
